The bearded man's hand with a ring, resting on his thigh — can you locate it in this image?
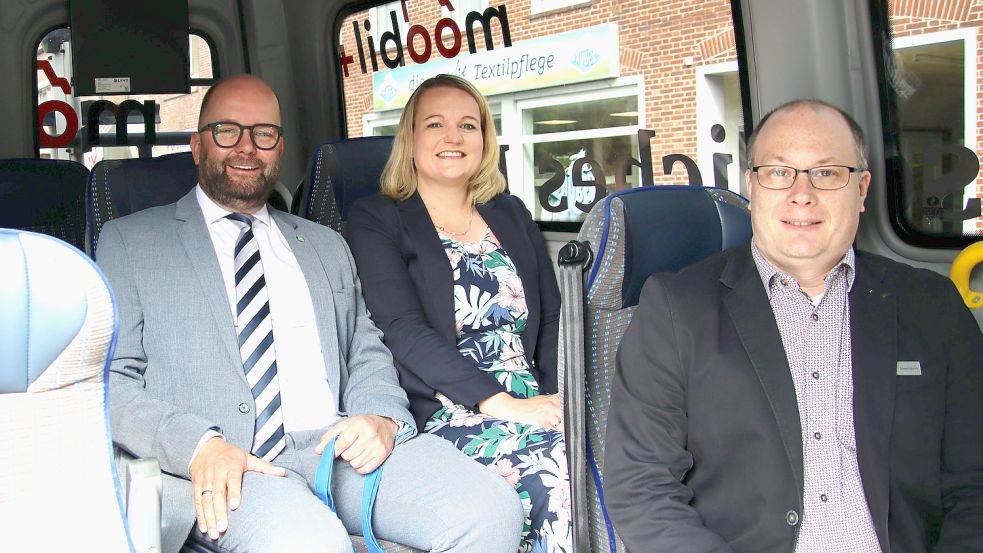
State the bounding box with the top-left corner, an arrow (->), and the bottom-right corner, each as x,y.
189,437 -> 287,540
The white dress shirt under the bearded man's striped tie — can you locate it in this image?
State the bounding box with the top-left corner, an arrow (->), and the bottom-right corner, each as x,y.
195,185 -> 340,432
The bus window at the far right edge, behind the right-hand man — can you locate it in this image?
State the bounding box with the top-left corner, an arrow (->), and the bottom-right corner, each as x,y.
885,1 -> 983,246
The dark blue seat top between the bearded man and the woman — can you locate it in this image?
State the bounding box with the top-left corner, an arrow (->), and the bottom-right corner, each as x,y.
298,136 -> 393,232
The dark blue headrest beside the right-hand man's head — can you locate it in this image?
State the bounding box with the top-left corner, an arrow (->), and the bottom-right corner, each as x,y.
588,186 -> 751,307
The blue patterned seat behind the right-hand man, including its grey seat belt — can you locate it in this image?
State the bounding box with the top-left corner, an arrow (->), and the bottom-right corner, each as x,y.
560,186 -> 751,553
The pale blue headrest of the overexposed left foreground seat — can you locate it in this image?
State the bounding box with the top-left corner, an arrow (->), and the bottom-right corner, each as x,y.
0,229 -> 96,393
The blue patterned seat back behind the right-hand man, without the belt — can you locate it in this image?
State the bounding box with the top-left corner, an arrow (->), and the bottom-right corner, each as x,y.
564,186 -> 751,553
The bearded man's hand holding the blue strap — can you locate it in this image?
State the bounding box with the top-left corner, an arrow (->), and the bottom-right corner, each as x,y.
314,415 -> 397,474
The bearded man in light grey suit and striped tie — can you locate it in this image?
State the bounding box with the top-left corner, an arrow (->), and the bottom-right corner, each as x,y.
98,75 -> 522,553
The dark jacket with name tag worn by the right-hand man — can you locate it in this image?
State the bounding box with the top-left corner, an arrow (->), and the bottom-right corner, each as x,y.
604,245 -> 983,553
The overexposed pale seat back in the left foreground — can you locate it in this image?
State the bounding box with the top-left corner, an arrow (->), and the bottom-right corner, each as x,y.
0,229 -> 133,551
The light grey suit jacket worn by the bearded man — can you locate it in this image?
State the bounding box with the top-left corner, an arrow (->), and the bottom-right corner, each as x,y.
98,190 -> 413,551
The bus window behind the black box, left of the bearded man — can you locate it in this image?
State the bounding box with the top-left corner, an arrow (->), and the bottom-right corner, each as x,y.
36,27 -> 218,169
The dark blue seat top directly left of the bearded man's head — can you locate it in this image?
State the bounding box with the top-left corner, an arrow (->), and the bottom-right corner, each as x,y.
86,152 -> 198,257
